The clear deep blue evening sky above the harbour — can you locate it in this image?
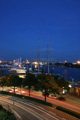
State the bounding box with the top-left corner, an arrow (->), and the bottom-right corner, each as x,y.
0,0 -> 80,62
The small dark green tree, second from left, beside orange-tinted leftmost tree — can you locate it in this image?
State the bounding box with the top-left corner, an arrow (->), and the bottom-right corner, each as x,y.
9,74 -> 22,94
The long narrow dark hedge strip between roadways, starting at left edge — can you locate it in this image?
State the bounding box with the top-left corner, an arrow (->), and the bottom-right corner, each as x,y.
0,91 -> 53,107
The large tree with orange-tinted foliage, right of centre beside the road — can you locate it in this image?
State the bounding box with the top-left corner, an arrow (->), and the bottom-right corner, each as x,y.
37,74 -> 59,102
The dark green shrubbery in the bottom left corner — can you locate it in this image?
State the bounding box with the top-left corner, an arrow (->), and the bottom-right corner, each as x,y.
0,105 -> 16,120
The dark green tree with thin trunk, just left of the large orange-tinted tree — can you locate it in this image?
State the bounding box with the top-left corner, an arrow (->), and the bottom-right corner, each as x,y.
23,73 -> 37,97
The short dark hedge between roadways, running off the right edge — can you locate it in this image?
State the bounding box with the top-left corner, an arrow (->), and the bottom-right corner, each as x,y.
56,106 -> 80,118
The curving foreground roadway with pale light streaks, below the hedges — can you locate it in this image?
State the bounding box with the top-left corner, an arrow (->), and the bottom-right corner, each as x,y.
0,96 -> 78,120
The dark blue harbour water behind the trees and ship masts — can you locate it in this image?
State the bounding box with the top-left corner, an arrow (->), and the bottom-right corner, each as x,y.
0,65 -> 80,81
